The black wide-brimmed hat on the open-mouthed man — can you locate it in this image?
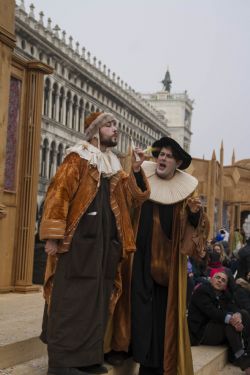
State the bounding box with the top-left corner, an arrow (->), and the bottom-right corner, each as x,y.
152,137 -> 192,169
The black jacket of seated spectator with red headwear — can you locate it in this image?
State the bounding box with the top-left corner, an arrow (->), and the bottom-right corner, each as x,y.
188,282 -> 239,345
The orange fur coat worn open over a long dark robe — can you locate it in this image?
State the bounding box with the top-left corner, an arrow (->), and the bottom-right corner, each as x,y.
40,153 -> 150,310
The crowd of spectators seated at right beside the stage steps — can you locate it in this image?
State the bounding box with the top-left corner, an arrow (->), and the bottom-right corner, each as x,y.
187,229 -> 250,375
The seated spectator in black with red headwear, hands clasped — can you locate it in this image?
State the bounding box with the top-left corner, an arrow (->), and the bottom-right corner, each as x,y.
188,269 -> 250,375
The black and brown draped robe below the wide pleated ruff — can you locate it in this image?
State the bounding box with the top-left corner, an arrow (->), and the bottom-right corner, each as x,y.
132,200 -> 208,375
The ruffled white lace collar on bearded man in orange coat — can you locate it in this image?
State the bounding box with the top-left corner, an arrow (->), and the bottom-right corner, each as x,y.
66,141 -> 122,177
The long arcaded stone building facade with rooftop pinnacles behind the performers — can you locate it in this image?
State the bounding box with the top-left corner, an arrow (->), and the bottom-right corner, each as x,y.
15,0 -> 170,209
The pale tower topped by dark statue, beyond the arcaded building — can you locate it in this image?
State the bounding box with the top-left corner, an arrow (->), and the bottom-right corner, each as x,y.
143,70 -> 193,152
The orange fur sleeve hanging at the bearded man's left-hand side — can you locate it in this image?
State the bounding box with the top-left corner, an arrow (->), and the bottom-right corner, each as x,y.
39,153 -> 83,240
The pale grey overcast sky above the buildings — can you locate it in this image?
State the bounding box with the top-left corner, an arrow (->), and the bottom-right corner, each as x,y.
22,0 -> 250,164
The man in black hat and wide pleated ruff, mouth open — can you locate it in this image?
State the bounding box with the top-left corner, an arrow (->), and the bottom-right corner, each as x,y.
132,137 -> 208,375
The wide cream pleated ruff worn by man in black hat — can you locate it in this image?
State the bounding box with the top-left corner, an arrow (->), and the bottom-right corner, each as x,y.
142,161 -> 198,204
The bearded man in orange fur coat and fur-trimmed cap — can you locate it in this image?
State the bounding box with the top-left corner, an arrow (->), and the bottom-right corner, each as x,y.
40,112 -> 149,375
